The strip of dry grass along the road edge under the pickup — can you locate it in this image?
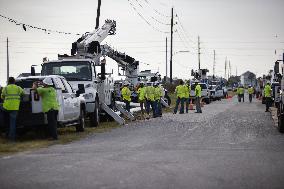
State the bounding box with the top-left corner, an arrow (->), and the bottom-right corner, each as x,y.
0,122 -> 120,155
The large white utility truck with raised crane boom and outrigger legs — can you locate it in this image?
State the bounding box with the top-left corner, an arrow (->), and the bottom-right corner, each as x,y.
41,20 -> 137,126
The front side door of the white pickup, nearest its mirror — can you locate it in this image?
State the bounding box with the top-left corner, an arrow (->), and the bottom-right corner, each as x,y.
61,78 -> 80,120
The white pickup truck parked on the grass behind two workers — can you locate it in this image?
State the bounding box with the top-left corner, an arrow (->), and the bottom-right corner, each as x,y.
16,75 -> 86,132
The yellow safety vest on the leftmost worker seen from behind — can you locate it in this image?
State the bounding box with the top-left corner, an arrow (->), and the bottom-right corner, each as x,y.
1,84 -> 24,111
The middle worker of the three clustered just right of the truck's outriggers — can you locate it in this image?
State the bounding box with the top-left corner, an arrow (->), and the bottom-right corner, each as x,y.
145,82 -> 156,119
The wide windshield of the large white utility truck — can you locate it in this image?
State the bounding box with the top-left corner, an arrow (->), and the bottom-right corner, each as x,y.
42,61 -> 92,81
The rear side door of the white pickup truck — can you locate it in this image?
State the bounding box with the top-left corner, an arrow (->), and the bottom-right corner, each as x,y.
54,78 -> 73,121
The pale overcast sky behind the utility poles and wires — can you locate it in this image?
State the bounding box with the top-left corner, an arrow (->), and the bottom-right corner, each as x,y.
0,0 -> 284,85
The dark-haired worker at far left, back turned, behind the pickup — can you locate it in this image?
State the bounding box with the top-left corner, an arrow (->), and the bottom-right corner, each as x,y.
1,77 -> 24,141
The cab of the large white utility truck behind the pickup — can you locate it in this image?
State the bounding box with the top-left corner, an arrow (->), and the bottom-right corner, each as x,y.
41,57 -> 114,126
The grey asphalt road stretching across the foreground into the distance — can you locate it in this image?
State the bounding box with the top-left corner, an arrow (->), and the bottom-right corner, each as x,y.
0,96 -> 284,189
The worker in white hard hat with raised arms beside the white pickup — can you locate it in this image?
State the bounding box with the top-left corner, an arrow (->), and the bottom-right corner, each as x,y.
33,77 -> 59,140
